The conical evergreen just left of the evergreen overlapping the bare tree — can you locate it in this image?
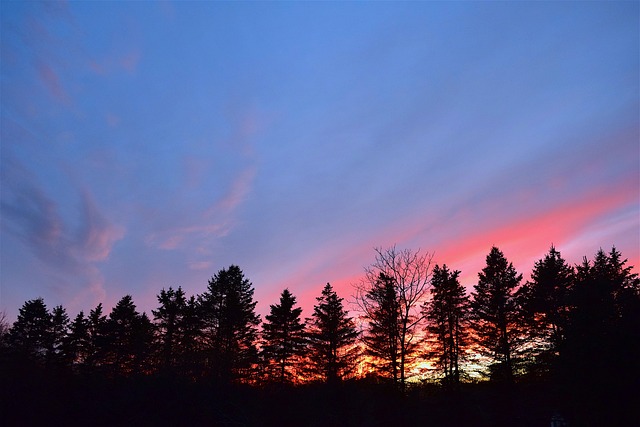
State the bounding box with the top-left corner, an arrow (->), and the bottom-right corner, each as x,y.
307,283 -> 358,383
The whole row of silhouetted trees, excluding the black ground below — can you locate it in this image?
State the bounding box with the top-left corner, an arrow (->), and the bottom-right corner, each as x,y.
0,246 -> 640,393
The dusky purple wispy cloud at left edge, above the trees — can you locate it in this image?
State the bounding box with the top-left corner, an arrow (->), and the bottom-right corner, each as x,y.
1,152 -> 125,308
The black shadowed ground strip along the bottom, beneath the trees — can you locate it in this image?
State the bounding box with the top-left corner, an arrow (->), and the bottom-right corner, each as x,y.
0,365 -> 639,427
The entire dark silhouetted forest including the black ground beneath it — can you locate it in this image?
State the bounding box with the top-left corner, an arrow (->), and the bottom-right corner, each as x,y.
0,246 -> 640,427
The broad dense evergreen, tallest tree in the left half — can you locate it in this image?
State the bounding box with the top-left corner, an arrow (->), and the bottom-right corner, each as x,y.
199,265 -> 260,382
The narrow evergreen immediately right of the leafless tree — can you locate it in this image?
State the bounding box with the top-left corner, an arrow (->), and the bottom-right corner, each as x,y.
424,264 -> 470,386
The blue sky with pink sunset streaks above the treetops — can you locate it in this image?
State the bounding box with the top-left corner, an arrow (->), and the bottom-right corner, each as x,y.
0,1 -> 640,320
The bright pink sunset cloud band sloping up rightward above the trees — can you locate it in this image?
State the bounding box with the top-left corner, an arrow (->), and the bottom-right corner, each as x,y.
261,174 -> 640,314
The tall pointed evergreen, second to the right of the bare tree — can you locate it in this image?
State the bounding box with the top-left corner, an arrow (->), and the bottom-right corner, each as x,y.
471,246 -> 522,382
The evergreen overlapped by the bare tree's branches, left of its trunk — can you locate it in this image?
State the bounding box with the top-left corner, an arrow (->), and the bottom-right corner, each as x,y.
363,273 -> 400,383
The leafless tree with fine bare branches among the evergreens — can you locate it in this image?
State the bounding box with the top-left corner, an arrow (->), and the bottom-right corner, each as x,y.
355,246 -> 433,389
